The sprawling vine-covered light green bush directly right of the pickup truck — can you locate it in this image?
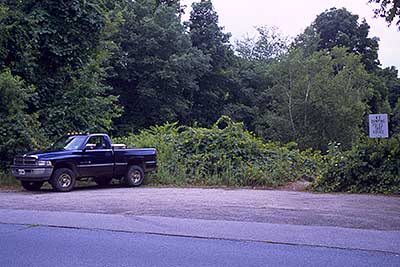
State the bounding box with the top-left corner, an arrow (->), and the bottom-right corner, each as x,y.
115,117 -> 321,186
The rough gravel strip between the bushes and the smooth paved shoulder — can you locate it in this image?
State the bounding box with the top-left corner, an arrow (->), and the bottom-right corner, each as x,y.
0,186 -> 400,230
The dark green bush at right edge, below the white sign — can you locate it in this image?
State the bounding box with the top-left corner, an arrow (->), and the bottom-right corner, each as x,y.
314,135 -> 400,194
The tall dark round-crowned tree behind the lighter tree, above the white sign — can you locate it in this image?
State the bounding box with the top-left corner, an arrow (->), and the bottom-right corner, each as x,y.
294,8 -> 390,120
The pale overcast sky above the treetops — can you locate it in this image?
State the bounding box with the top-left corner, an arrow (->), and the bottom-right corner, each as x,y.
181,0 -> 400,69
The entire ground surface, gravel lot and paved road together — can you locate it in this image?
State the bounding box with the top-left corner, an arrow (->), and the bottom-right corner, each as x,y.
0,187 -> 400,266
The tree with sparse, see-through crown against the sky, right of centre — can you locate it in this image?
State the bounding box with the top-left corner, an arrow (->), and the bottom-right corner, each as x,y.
223,26 -> 289,131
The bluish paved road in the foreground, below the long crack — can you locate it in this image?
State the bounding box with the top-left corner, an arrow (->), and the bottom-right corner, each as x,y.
0,225 -> 400,267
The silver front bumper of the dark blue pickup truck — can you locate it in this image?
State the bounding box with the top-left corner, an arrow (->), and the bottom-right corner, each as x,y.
11,165 -> 53,181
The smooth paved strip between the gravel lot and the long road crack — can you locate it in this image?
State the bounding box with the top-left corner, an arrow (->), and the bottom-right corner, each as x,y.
0,209 -> 400,255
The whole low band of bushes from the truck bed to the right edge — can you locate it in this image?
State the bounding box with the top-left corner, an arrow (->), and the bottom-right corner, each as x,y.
114,117 -> 400,194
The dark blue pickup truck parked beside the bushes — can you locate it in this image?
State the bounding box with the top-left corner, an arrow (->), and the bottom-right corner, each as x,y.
11,134 -> 157,192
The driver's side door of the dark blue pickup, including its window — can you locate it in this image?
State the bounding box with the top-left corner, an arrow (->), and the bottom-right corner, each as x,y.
78,135 -> 114,177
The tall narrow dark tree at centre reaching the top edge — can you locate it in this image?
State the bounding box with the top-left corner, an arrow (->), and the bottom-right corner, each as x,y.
186,0 -> 233,126
